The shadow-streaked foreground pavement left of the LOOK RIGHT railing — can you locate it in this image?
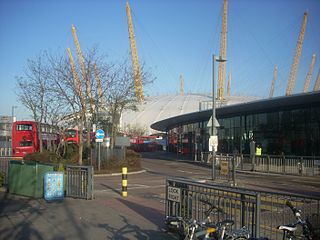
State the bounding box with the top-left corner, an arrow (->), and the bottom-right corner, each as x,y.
0,188 -> 174,240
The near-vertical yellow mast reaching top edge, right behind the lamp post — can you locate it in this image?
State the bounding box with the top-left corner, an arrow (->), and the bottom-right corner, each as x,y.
217,0 -> 228,100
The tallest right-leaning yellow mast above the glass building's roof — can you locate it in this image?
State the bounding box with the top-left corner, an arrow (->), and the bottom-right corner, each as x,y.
286,12 -> 308,96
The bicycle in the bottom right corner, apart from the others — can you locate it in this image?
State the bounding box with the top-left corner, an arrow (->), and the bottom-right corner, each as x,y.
277,201 -> 312,240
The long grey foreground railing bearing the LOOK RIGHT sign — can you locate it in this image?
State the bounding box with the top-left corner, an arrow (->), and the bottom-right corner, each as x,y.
165,179 -> 320,240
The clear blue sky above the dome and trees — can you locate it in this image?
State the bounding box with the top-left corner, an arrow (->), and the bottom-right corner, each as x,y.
0,0 -> 320,120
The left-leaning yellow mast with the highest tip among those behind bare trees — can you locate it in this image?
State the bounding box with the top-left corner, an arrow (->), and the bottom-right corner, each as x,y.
71,25 -> 93,110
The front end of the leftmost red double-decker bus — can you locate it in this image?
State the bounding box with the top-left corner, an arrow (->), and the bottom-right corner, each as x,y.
12,121 -> 40,157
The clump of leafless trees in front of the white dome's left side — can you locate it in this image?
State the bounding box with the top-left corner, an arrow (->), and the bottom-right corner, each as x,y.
17,49 -> 152,165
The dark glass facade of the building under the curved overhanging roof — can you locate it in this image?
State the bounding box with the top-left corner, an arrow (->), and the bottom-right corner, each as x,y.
151,92 -> 320,156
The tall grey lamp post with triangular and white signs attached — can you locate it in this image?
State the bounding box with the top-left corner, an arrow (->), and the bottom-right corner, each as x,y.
210,54 -> 227,180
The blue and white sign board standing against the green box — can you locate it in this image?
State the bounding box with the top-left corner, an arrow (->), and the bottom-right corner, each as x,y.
44,172 -> 64,201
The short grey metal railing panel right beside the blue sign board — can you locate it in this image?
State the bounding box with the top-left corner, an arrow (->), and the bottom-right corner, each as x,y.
65,165 -> 93,200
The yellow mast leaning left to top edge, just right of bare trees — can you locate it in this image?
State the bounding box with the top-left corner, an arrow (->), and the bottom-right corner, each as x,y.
126,1 -> 144,102
